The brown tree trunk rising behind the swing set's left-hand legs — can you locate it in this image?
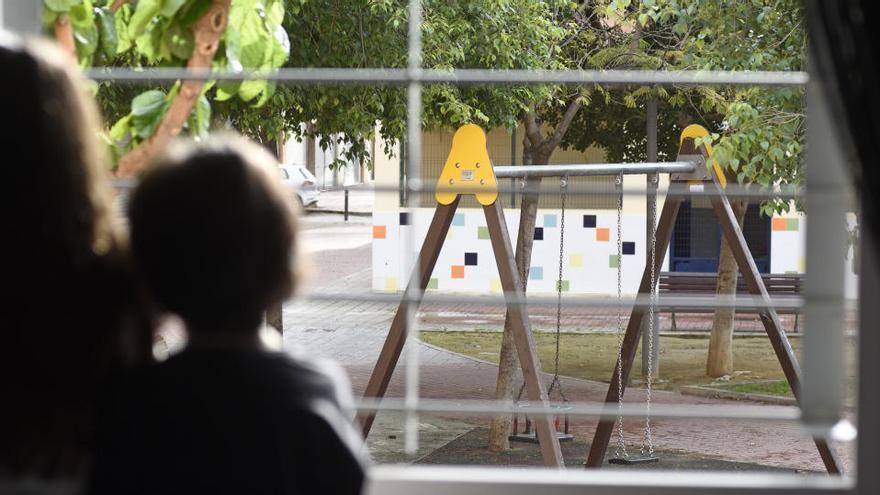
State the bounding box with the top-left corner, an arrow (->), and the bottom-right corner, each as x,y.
489,150 -> 550,452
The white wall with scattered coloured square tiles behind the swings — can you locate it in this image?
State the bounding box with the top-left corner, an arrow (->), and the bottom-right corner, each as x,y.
372,208 -> 856,295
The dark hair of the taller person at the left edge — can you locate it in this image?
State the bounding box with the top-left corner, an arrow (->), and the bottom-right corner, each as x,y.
0,32 -> 141,477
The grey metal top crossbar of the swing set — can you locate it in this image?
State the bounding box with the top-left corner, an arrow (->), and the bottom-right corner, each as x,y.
495,162 -> 695,179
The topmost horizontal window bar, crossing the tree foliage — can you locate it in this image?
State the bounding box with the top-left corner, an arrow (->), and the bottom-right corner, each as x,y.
86,67 -> 809,87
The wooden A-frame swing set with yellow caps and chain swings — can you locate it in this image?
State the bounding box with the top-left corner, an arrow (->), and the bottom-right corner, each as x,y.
360,124 -> 841,474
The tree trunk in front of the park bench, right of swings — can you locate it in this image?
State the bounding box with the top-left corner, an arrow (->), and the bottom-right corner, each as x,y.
706,200 -> 748,378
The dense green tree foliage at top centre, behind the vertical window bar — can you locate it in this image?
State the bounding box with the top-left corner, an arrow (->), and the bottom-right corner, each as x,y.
218,0 -> 561,167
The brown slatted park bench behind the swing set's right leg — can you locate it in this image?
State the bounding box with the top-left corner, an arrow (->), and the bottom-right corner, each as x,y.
657,272 -> 803,332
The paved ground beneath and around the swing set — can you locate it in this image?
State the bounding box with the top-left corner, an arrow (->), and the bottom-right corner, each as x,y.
284,214 -> 853,471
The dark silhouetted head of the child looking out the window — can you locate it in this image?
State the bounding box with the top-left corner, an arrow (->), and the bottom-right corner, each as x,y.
129,135 -> 296,336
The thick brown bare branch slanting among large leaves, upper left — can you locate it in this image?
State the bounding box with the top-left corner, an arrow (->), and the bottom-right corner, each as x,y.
116,0 -> 231,177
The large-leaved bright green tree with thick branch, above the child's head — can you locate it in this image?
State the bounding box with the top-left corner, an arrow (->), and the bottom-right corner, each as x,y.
44,0 -> 290,176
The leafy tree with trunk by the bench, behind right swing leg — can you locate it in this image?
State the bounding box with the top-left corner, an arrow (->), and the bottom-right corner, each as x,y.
664,0 -> 806,377
